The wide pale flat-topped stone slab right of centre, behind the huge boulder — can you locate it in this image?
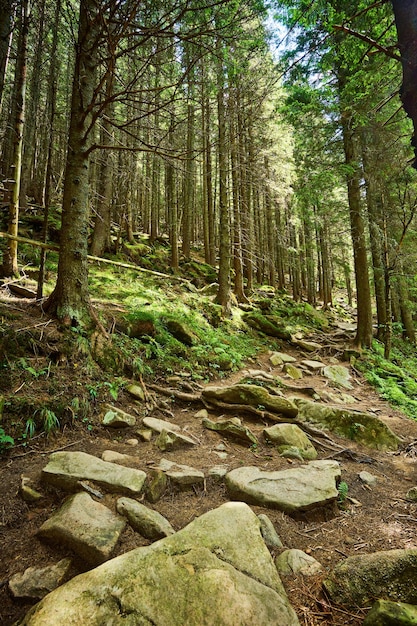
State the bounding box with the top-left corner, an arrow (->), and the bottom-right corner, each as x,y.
225,461 -> 340,513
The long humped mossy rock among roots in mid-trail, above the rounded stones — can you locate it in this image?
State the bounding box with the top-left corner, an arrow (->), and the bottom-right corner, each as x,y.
202,384 -> 298,417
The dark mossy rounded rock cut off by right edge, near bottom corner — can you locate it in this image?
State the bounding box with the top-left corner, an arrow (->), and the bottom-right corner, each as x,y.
324,549 -> 417,606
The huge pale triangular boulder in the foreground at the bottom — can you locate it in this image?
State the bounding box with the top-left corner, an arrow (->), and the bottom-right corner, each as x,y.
21,502 -> 299,626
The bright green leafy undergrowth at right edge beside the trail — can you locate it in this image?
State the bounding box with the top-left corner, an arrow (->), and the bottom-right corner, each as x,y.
355,338 -> 417,419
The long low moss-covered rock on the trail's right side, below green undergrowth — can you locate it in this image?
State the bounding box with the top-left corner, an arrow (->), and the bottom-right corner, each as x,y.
297,400 -> 400,450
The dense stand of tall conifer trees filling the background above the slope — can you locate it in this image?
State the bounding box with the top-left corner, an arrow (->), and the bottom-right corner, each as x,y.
0,0 -> 417,356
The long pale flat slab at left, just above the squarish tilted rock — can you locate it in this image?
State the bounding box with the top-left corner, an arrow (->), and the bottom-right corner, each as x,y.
42,452 -> 146,495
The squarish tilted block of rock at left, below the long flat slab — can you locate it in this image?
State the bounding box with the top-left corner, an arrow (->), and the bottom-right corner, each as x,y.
38,493 -> 126,565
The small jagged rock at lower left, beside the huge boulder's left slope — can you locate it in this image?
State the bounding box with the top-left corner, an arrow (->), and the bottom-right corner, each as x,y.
9,558 -> 71,600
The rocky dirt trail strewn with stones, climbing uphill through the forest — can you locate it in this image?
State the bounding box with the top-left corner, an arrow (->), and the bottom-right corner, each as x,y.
0,314 -> 417,626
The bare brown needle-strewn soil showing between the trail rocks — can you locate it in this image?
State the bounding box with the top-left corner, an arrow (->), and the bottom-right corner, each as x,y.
0,297 -> 417,626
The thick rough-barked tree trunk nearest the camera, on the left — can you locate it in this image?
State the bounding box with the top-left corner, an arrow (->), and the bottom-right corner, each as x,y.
45,0 -> 99,326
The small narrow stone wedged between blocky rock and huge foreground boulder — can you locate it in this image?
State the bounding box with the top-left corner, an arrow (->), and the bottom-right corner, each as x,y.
116,498 -> 175,541
